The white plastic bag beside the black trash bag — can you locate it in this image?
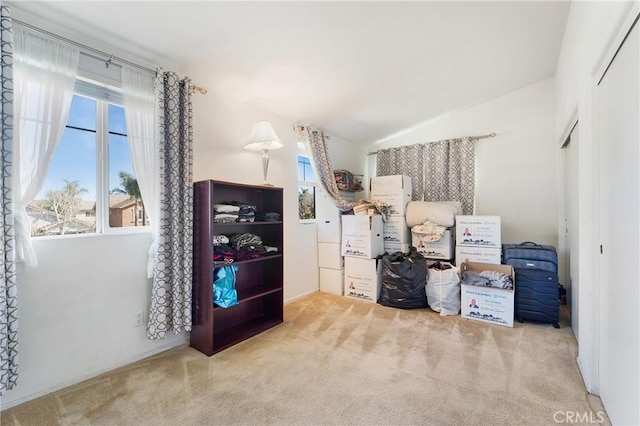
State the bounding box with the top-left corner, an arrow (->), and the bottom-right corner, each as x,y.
425,266 -> 460,316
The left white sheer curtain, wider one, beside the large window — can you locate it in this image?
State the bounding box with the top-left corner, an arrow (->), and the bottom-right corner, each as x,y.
13,26 -> 80,267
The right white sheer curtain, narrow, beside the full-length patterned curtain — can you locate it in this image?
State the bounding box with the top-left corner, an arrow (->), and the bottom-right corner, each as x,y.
122,66 -> 160,278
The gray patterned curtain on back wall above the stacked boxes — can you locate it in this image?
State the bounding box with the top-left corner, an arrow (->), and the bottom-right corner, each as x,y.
376,138 -> 476,214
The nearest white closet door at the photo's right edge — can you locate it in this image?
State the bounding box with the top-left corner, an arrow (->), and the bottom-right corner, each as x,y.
594,15 -> 640,425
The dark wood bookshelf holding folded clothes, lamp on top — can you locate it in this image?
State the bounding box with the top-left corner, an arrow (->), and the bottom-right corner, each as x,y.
190,180 -> 284,356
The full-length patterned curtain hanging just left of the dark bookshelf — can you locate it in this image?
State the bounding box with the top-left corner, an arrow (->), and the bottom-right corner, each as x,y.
147,72 -> 193,339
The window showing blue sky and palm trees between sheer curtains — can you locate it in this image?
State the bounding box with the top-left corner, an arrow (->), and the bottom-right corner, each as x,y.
27,90 -> 149,236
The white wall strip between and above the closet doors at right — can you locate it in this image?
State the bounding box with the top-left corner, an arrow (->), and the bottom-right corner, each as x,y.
555,1 -> 637,402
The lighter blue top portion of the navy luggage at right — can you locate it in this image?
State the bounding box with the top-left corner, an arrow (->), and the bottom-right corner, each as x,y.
502,241 -> 558,272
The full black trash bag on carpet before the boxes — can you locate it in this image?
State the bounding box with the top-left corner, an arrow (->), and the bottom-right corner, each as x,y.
378,248 -> 427,309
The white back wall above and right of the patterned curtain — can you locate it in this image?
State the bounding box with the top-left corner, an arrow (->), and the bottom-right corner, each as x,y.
369,79 -> 558,245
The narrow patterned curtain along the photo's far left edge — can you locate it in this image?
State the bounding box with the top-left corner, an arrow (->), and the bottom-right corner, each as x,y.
0,6 -> 18,397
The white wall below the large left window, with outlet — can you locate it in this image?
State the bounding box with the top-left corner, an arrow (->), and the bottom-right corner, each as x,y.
2,233 -> 188,409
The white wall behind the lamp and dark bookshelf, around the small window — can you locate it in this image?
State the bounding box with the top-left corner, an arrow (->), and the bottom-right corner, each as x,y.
188,82 -> 365,301
